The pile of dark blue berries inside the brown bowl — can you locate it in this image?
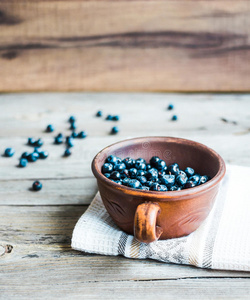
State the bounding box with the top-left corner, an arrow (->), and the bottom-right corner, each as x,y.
102,155 -> 210,192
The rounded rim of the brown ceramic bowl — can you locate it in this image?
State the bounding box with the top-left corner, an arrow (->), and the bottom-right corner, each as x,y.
91,136 -> 226,201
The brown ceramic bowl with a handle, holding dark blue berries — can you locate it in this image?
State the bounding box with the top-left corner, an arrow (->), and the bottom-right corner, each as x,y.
92,137 -> 226,243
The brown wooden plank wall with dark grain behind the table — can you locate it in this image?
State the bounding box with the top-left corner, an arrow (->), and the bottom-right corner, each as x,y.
0,0 -> 250,92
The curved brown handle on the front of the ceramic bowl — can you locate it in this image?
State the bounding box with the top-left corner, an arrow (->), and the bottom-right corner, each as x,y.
134,202 -> 163,244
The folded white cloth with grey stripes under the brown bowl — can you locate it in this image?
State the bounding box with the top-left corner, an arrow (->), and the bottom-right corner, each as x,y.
72,166 -> 250,271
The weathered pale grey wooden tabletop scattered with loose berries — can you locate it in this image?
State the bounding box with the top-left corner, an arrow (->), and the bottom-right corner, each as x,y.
0,93 -> 250,299
